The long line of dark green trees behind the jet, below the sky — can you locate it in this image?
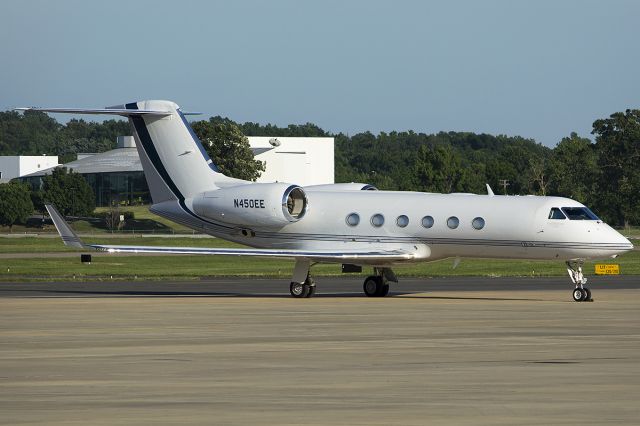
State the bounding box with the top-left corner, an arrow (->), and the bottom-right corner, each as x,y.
0,110 -> 640,226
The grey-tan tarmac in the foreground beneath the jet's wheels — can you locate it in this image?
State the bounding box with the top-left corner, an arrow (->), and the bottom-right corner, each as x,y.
0,277 -> 640,425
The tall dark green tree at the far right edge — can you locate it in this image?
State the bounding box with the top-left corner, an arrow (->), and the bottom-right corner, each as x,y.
591,109 -> 640,226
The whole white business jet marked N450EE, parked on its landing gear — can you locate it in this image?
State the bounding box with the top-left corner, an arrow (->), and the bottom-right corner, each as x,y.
21,101 -> 633,301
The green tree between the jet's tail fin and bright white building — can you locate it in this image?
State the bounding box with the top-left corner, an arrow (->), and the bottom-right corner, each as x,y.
192,120 -> 265,181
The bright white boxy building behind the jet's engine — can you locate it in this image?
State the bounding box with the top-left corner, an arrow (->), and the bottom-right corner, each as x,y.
248,136 -> 335,186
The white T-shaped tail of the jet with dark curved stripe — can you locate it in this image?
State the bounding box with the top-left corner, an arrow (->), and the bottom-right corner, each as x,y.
18,101 -> 245,204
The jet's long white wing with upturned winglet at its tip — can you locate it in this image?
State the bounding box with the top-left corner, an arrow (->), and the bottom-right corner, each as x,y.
45,204 -> 424,263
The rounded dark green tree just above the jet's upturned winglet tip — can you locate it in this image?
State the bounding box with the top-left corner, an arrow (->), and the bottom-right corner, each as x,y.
42,167 -> 96,216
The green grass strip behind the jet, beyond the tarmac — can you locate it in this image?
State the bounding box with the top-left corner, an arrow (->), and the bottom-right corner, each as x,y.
0,238 -> 640,281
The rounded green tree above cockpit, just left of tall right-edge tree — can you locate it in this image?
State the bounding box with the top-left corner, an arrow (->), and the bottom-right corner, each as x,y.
550,132 -> 599,205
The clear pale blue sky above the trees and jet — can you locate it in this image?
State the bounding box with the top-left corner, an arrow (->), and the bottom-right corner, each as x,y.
0,0 -> 640,146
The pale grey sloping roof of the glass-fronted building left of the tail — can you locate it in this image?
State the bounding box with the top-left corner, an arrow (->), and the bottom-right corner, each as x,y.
24,148 -> 142,177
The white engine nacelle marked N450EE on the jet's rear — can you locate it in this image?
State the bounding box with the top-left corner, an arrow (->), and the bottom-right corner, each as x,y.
193,183 -> 307,227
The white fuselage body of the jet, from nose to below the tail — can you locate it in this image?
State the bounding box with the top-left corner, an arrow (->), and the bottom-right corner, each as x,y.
153,190 -> 633,260
